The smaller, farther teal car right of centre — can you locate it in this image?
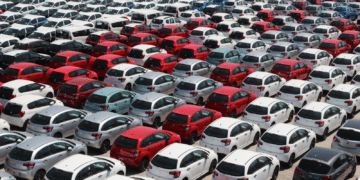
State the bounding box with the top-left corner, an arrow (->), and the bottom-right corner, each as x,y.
206,48 -> 245,66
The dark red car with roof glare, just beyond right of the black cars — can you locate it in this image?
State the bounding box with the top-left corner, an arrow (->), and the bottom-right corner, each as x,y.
86,31 -> 127,47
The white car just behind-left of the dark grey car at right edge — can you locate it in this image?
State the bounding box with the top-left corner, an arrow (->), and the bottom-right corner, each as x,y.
294,102 -> 347,140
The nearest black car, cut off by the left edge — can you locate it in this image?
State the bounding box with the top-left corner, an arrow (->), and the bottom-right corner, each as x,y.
0,50 -> 51,69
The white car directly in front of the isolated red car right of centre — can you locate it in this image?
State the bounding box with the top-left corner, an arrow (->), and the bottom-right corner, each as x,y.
276,79 -> 322,108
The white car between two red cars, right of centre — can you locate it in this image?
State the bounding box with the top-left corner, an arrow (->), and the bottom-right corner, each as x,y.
240,71 -> 286,97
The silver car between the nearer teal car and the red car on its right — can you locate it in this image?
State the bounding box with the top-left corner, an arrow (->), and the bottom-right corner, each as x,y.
129,92 -> 186,128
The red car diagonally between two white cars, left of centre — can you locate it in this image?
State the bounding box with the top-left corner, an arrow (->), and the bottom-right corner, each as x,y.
91,54 -> 135,78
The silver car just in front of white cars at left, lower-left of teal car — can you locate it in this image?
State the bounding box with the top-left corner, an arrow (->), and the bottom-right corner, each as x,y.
26,106 -> 92,138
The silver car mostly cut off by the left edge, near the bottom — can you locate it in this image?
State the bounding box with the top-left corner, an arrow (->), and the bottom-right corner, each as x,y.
0,130 -> 34,165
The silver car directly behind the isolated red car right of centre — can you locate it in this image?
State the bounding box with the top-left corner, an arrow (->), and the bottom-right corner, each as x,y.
268,42 -> 301,60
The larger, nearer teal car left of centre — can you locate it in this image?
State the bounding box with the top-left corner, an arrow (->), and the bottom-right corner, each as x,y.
84,87 -> 141,114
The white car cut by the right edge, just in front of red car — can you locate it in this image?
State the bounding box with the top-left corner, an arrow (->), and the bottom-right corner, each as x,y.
331,53 -> 360,77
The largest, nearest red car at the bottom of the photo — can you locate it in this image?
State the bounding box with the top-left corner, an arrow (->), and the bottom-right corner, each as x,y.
110,126 -> 181,171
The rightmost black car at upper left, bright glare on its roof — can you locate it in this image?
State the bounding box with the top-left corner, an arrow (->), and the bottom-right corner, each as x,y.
46,40 -> 92,56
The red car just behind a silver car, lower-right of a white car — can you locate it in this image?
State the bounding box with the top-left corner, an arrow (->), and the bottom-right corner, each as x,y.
144,53 -> 180,74
